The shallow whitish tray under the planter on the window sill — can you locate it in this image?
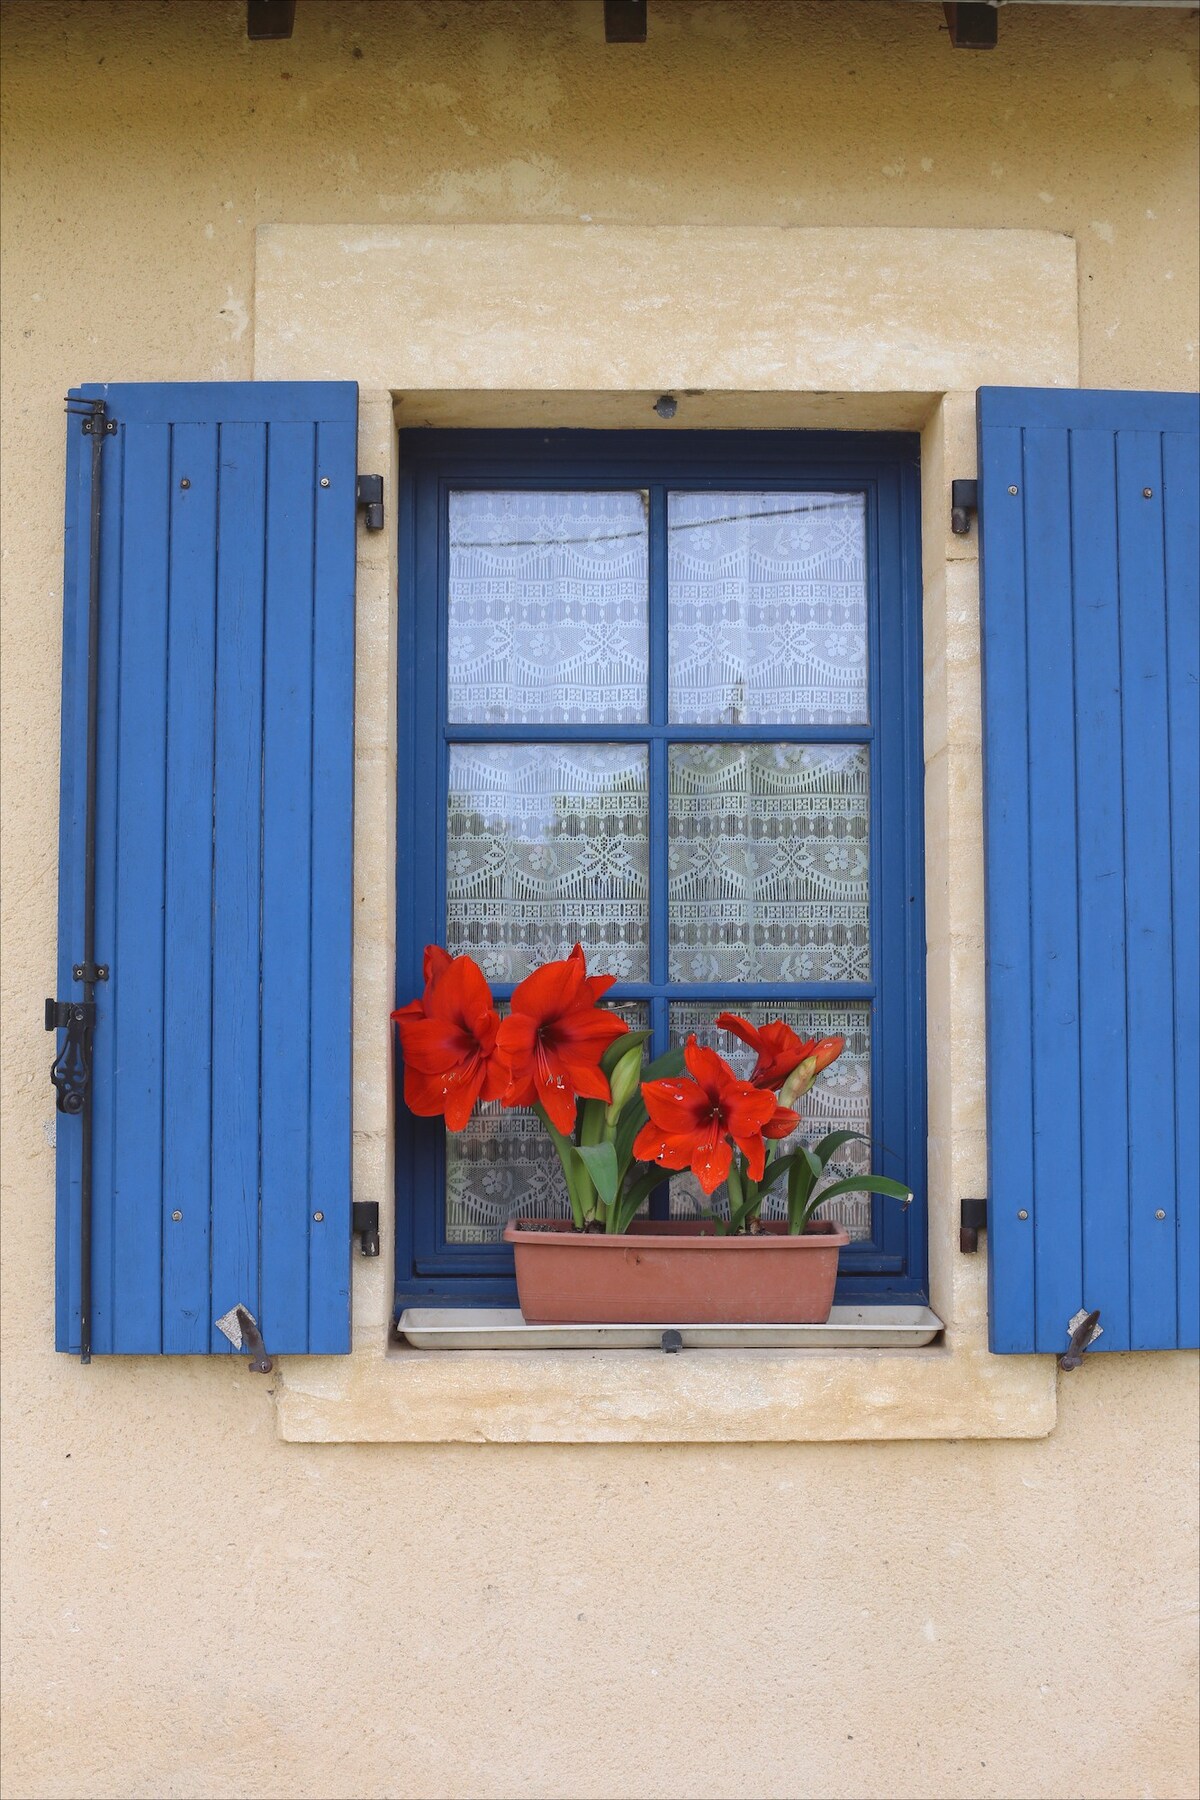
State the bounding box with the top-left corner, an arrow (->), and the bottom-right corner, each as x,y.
396,1307 -> 943,1350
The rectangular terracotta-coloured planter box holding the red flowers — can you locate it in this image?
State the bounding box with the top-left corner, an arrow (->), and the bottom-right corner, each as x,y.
504,1219 -> 849,1325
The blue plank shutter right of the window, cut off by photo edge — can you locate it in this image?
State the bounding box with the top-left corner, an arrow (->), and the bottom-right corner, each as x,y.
979,389 -> 1200,1350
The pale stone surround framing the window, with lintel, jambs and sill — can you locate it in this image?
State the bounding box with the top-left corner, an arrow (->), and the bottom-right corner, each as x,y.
254,223 -> 1078,1444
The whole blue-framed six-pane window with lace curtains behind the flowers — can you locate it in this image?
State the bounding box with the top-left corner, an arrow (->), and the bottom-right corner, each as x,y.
396,432 -> 925,1305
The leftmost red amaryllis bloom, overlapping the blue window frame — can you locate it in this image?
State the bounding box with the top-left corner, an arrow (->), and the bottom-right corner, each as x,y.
392,943 -> 509,1130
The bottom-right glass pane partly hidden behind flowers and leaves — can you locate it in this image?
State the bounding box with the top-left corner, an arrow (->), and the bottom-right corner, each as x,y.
671,999 -> 878,1238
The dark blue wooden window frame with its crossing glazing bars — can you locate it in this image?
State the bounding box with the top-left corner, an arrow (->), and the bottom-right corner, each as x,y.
396,430 -> 927,1309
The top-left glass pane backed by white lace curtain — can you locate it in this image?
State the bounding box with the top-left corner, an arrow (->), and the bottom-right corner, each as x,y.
450,493 -> 649,725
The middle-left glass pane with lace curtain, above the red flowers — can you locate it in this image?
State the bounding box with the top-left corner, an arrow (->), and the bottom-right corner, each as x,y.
446,743 -> 649,981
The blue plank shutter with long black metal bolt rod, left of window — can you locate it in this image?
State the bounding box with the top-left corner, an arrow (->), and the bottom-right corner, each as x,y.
58,382 -> 358,1354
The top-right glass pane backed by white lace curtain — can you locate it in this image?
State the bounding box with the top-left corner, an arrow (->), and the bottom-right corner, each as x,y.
667,493 -> 867,725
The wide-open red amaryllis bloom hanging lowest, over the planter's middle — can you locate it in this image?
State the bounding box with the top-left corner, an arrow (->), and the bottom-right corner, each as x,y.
633,1037 -> 801,1193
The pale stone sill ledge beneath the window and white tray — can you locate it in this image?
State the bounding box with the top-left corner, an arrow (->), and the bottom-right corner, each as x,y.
275,1328 -> 1056,1444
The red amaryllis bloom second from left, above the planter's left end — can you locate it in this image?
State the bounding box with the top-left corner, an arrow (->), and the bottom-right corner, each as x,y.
498,945 -> 628,1136
